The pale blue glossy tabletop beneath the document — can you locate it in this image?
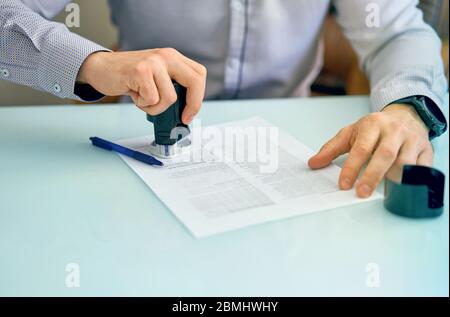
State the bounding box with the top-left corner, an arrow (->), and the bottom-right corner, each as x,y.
0,97 -> 449,296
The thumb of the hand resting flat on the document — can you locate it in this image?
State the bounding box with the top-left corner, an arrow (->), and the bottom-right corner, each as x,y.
308,126 -> 353,169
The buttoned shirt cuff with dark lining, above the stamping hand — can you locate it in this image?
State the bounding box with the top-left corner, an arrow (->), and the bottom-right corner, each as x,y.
38,31 -> 110,101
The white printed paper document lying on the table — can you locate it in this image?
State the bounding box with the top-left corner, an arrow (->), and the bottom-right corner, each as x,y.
117,117 -> 382,238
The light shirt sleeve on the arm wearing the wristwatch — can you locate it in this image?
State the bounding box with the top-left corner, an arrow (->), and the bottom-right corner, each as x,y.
334,0 -> 448,111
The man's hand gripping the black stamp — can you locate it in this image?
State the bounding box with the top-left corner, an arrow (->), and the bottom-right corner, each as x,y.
77,48 -> 206,124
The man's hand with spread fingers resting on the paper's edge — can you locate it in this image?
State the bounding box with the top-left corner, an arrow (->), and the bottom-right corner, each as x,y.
308,104 -> 433,197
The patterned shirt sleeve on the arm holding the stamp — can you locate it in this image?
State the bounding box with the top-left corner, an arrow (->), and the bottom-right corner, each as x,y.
0,0 -> 108,101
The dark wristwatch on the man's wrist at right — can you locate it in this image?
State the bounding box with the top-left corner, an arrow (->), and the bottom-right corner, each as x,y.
393,96 -> 447,140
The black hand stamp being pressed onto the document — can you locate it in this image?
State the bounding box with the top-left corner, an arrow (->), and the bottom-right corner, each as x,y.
147,82 -> 189,145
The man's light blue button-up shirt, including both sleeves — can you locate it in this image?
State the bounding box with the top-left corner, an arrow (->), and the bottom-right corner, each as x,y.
0,0 -> 447,111
